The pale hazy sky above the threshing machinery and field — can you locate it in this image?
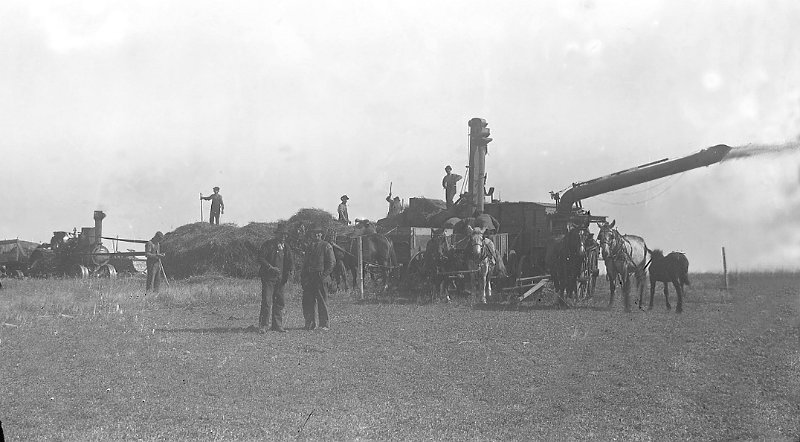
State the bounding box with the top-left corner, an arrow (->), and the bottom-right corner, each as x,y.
0,0 -> 800,271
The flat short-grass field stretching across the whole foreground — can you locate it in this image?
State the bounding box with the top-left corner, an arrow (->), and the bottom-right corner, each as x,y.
0,273 -> 800,441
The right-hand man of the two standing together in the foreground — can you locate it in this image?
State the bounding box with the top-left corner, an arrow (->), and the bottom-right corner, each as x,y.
300,228 -> 336,330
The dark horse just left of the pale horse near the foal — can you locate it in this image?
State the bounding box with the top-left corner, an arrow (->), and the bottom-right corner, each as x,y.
545,227 -> 588,305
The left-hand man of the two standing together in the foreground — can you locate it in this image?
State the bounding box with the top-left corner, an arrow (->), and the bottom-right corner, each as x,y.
258,224 -> 294,333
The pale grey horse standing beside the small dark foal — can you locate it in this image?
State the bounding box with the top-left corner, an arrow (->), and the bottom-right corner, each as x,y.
597,220 -> 648,312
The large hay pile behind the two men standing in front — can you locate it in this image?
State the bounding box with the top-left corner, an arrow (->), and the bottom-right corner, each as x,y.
161,208 -> 344,278
